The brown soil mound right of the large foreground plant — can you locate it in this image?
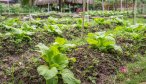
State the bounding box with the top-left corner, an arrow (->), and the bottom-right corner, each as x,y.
68,45 -> 122,84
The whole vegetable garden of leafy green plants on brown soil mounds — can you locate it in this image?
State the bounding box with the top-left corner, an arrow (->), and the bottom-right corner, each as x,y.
0,0 -> 146,84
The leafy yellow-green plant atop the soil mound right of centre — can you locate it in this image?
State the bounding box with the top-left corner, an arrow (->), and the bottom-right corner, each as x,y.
87,32 -> 122,52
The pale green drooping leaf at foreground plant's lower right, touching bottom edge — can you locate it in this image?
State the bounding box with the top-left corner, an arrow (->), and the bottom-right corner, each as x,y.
61,69 -> 81,84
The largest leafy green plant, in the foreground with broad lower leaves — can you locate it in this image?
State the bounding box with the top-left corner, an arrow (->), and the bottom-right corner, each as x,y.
37,38 -> 80,84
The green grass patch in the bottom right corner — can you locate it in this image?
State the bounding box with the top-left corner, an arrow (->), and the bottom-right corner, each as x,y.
118,57 -> 146,84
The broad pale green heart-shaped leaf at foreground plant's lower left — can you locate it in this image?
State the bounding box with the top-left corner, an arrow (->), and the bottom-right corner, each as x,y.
37,65 -> 58,80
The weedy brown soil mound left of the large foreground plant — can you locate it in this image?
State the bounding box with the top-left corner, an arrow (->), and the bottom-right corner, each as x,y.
0,51 -> 45,84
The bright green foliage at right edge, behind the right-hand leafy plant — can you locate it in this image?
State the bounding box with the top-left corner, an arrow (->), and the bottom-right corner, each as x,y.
115,24 -> 146,40
